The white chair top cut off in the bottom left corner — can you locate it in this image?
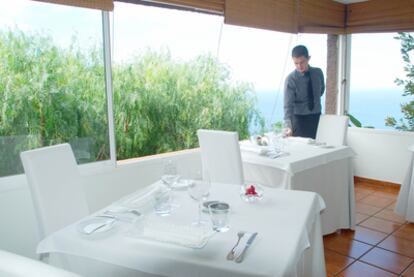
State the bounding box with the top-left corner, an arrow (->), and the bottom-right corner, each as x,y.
0,250 -> 80,277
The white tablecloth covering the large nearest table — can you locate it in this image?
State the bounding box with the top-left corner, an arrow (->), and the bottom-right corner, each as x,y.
38,184 -> 326,277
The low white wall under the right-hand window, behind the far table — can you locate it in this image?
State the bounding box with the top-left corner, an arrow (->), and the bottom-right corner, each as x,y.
348,128 -> 414,184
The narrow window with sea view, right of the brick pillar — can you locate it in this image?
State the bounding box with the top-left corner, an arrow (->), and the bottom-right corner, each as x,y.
349,33 -> 408,129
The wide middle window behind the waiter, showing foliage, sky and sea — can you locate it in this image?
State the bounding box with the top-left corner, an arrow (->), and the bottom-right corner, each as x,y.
112,2 -> 326,160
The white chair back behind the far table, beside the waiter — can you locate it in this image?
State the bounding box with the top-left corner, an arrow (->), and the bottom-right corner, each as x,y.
316,114 -> 349,146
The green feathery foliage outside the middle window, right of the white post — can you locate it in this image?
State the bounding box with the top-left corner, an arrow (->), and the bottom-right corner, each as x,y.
113,50 -> 260,159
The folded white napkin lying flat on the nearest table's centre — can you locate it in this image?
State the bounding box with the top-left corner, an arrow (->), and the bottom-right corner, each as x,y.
140,219 -> 214,248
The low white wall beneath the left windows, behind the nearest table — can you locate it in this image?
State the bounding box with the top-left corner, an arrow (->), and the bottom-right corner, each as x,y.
0,150 -> 201,258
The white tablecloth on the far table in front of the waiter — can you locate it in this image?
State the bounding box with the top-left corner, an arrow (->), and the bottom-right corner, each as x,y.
241,140 -> 355,235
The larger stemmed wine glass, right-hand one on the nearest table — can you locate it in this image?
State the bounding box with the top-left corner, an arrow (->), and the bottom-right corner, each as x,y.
188,172 -> 211,226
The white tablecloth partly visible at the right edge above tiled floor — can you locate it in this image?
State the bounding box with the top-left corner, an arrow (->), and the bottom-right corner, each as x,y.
395,146 -> 414,222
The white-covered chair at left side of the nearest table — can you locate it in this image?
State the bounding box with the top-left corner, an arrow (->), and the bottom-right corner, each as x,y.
20,143 -> 89,239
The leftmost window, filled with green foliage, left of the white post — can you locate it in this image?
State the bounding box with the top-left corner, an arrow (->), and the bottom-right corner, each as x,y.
0,0 -> 109,177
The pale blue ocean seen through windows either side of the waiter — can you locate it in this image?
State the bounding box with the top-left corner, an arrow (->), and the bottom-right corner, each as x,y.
250,88 -> 411,130
